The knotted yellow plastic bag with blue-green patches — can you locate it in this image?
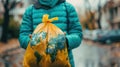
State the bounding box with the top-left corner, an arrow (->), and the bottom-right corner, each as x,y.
23,14 -> 71,67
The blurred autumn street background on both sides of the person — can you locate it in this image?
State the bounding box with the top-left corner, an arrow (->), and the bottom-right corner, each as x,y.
0,0 -> 120,67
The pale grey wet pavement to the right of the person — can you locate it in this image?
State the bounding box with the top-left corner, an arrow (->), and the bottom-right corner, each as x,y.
73,41 -> 120,67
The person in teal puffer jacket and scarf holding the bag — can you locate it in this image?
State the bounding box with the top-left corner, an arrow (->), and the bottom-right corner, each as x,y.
19,0 -> 82,67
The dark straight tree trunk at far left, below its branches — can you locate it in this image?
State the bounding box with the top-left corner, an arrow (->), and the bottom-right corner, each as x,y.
1,0 -> 9,42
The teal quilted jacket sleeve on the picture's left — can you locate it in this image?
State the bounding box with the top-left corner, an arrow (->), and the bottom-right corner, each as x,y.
19,6 -> 33,49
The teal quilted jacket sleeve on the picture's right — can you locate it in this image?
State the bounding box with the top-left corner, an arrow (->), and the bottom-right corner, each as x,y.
66,3 -> 82,50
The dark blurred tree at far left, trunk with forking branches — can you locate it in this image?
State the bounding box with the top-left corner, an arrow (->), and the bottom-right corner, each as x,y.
1,0 -> 16,42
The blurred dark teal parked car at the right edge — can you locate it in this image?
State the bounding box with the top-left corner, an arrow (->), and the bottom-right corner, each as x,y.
94,30 -> 120,44
